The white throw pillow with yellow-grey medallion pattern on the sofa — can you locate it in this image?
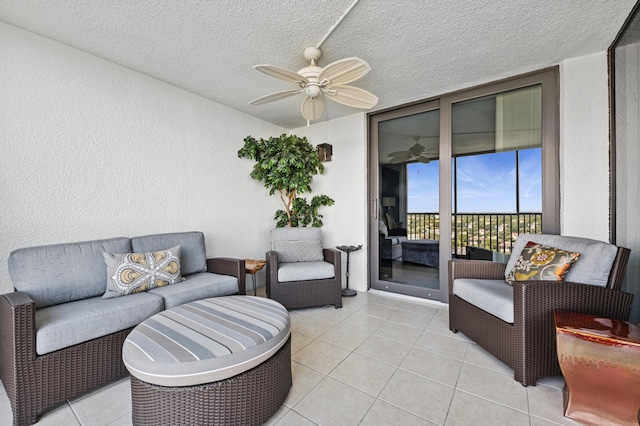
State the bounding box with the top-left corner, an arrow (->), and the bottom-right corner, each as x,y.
102,246 -> 182,299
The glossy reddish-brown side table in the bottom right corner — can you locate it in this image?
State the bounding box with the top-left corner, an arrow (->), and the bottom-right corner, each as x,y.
554,311 -> 640,425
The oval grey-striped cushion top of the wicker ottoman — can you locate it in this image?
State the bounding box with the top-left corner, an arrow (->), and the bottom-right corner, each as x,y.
122,296 -> 291,386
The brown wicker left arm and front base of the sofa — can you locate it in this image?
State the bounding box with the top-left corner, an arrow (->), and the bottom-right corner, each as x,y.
0,292 -> 132,426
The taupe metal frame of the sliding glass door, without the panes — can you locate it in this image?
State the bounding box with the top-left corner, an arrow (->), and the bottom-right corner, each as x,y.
367,66 -> 560,303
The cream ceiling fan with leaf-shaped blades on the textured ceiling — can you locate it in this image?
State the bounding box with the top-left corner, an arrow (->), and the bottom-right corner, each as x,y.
249,46 -> 378,121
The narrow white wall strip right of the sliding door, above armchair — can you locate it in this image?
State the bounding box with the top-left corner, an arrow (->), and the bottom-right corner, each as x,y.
560,52 -> 609,241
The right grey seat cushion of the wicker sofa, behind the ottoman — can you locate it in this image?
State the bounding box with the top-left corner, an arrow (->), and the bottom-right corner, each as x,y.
148,272 -> 239,309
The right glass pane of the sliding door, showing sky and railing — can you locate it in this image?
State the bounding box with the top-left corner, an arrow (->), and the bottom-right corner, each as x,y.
451,84 -> 542,263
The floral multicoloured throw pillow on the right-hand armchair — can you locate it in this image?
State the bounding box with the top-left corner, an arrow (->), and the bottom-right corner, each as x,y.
505,241 -> 580,285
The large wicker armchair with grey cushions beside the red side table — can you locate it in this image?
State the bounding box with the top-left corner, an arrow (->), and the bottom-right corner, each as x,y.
449,234 -> 633,386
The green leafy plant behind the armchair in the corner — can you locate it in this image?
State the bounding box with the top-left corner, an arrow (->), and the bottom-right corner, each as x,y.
238,133 -> 334,228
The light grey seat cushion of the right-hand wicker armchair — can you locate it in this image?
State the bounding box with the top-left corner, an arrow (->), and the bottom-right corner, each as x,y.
453,278 -> 513,324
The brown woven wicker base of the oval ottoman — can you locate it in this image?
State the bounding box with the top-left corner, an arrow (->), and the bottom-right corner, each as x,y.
131,337 -> 292,426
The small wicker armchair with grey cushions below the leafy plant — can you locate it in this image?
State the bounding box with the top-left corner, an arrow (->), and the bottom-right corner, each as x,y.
266,228 -> 342,309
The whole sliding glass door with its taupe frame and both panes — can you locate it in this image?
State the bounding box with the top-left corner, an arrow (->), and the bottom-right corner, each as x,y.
369,68 -> 559,302
